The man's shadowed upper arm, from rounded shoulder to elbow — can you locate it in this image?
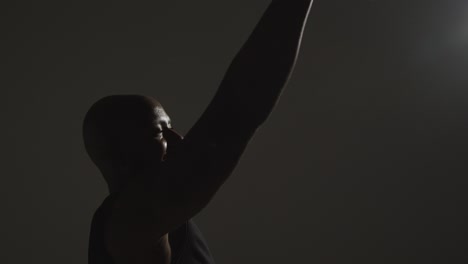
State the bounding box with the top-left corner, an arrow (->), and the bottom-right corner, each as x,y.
107,113 -> 256,254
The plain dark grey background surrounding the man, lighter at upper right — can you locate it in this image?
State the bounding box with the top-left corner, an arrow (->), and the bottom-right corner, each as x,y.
0,0 -> 468,264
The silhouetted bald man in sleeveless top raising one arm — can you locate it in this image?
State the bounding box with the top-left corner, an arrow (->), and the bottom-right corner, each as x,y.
83,0 -> 312,264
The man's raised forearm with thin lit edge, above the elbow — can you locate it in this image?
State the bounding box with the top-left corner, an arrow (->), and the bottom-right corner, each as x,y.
213,0 -> 312,125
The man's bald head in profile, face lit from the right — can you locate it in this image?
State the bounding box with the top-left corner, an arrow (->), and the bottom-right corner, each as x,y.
83,95 -> 170,186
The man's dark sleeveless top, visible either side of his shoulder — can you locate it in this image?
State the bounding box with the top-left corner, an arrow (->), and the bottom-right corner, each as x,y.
88,194 -> 214,264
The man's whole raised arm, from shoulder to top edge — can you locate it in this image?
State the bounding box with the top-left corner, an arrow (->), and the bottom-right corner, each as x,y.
110,0 -> 312,254
